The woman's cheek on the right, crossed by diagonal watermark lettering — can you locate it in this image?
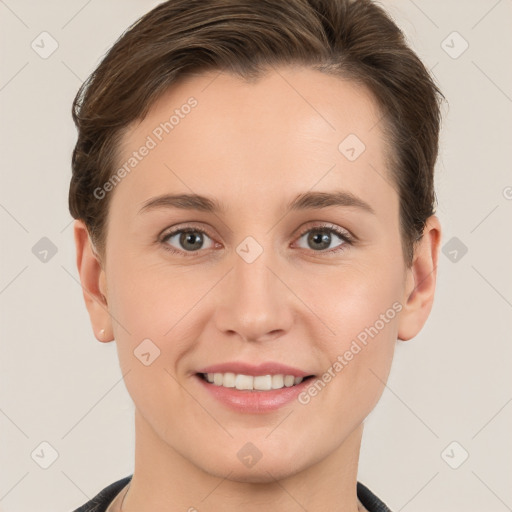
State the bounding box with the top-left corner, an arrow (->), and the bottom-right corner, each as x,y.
304,244 -> 404,392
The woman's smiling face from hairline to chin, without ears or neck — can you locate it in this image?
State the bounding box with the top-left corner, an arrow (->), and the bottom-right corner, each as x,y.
78,68 -> 434,481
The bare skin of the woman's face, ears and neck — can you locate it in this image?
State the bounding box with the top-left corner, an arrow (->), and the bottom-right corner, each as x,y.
74,67 -> 441,512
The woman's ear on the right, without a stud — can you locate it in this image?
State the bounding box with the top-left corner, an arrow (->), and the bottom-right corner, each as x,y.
398,215 -> 441,341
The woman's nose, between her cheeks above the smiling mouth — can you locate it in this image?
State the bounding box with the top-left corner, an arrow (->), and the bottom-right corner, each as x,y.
215,244 -> 297,342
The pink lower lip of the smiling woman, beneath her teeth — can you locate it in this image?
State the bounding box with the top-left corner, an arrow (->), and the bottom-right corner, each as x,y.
194,374 -> 311,414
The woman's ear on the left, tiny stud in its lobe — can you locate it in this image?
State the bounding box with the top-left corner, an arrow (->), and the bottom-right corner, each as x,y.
74,220 -> 114,342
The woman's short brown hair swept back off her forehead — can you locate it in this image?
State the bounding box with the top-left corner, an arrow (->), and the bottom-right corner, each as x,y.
69,0 -> 444,266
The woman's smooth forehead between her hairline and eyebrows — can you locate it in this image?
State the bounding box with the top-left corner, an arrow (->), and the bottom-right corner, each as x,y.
108,68 -> 396,220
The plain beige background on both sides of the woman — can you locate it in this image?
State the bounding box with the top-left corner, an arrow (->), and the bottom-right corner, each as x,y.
0,0 -> 512,512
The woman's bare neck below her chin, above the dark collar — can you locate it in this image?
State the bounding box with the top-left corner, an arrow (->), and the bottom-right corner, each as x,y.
122,410 -> 364,512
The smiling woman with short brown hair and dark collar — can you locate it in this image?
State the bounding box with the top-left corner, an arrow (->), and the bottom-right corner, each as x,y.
69,0 -> 442,512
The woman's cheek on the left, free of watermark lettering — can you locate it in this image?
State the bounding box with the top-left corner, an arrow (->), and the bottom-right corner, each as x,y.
105,252 -> 212,392
